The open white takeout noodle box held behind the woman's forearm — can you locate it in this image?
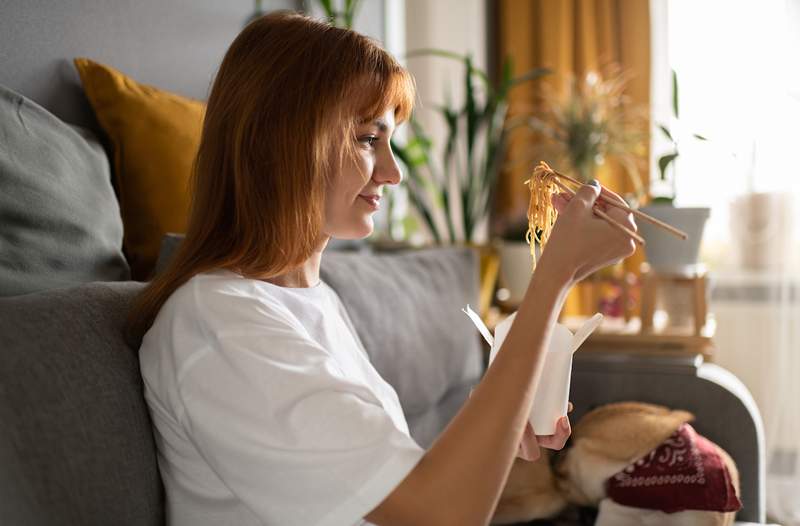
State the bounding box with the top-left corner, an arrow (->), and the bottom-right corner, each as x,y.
463,305 -> 603,435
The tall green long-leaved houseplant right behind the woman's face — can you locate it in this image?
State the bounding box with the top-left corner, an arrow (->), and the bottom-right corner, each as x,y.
392,50 -> 549,243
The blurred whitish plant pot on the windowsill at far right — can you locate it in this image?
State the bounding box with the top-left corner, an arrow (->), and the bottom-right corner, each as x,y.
730,192 -> 792,270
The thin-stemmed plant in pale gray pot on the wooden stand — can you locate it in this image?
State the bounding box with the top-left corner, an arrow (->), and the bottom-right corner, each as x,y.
639,71 -> 710,274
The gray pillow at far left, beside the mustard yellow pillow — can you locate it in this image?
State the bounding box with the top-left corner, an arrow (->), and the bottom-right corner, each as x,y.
0,86 -> 130,296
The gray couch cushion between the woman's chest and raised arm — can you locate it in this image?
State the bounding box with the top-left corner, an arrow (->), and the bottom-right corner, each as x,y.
321,247 -> 482,447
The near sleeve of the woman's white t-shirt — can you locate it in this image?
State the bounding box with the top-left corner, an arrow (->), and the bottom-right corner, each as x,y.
178,294 -> 424,526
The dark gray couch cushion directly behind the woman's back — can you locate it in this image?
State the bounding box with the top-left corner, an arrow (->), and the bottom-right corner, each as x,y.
0,282 -> 164,526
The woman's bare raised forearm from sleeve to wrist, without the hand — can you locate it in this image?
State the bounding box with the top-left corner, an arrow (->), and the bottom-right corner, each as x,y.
368,261 -> 571,524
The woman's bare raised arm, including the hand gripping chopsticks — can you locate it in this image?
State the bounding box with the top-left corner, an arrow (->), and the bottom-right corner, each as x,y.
366,186 -> 635,526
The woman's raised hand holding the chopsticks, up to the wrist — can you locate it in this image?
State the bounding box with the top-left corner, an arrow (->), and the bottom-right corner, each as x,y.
537,182 -> 636,283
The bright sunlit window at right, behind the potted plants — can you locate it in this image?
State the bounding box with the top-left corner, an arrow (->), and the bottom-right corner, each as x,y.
653,0 -> 800,268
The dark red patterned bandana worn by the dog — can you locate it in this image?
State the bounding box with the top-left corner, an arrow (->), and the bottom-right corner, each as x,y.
606,424 -> 742,513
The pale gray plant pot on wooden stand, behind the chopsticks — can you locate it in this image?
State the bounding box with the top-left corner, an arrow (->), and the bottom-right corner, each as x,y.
637,205 -> 710,274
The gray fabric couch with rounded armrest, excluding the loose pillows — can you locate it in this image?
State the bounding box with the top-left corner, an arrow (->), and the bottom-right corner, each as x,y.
0,249 -> 764,525
